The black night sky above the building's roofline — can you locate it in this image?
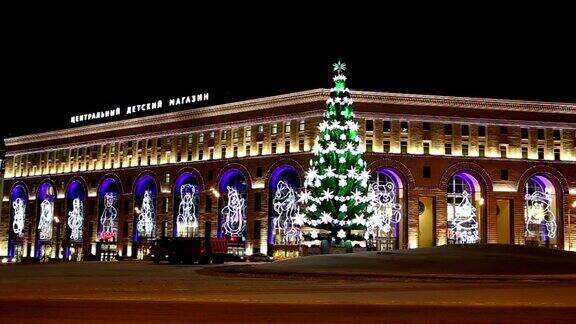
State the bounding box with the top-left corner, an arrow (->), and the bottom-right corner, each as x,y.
0,11 -> 576,143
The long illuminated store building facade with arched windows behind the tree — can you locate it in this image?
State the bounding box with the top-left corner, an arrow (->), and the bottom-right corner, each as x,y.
0,89 -> 576,260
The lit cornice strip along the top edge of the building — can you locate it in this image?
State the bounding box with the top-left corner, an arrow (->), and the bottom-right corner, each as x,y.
5,89 -> 576,147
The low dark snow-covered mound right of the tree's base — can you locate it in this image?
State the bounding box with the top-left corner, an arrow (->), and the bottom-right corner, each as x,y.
254,244 -> 576,275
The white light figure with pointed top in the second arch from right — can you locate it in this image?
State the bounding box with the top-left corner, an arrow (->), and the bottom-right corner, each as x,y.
448,190 -> 478,243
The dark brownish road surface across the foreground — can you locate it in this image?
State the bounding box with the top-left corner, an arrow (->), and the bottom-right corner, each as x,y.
0,262 -> 576,323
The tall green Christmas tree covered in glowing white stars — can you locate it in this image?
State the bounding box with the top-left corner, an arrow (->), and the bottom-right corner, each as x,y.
299,61 -> 369,244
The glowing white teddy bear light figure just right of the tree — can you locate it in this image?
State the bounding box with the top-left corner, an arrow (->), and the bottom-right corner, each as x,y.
366,182 -> 402,237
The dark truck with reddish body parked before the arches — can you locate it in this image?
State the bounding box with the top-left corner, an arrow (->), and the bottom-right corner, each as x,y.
150,237 -> 228,264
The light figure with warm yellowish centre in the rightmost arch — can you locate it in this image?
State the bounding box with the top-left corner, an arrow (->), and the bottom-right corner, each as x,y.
524,189 -> 557,238
